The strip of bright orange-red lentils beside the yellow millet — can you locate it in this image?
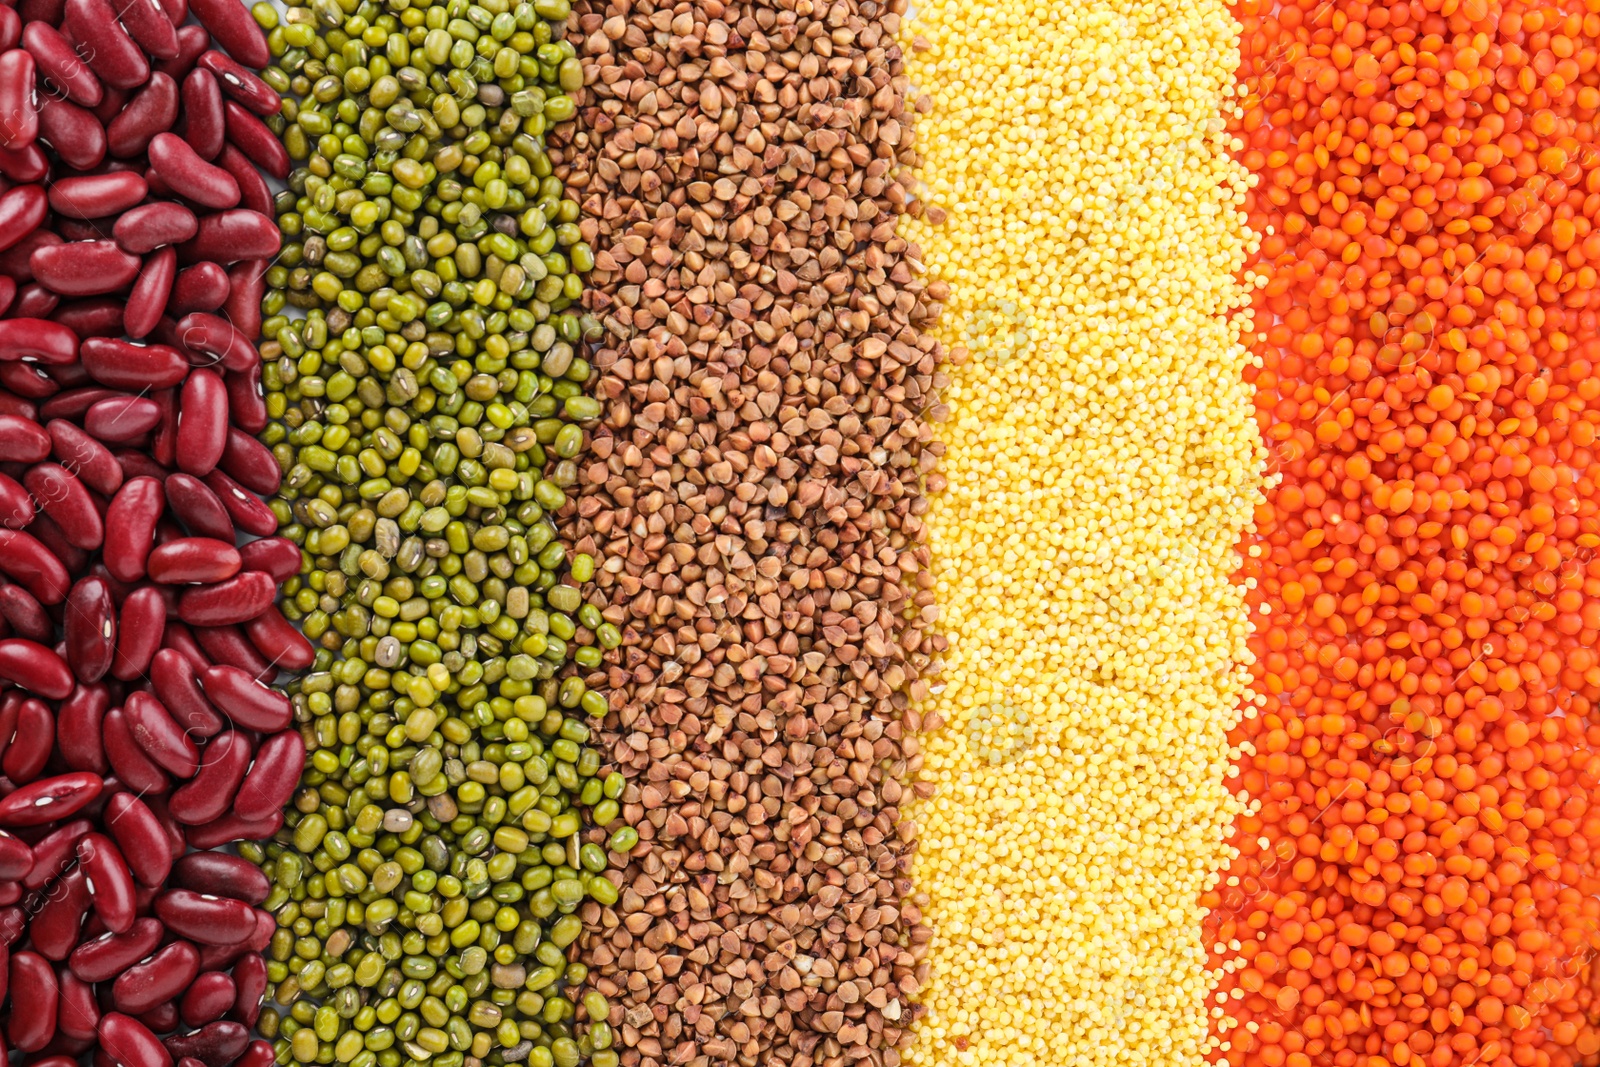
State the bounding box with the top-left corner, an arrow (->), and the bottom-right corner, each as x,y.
1203,0 -> 1600,1067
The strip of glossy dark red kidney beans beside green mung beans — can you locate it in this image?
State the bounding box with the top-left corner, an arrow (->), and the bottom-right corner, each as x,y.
0,0 -> 312,1067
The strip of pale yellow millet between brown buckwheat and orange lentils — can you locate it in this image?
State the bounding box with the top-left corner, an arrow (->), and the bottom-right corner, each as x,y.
904,0 -> 1262,1067
